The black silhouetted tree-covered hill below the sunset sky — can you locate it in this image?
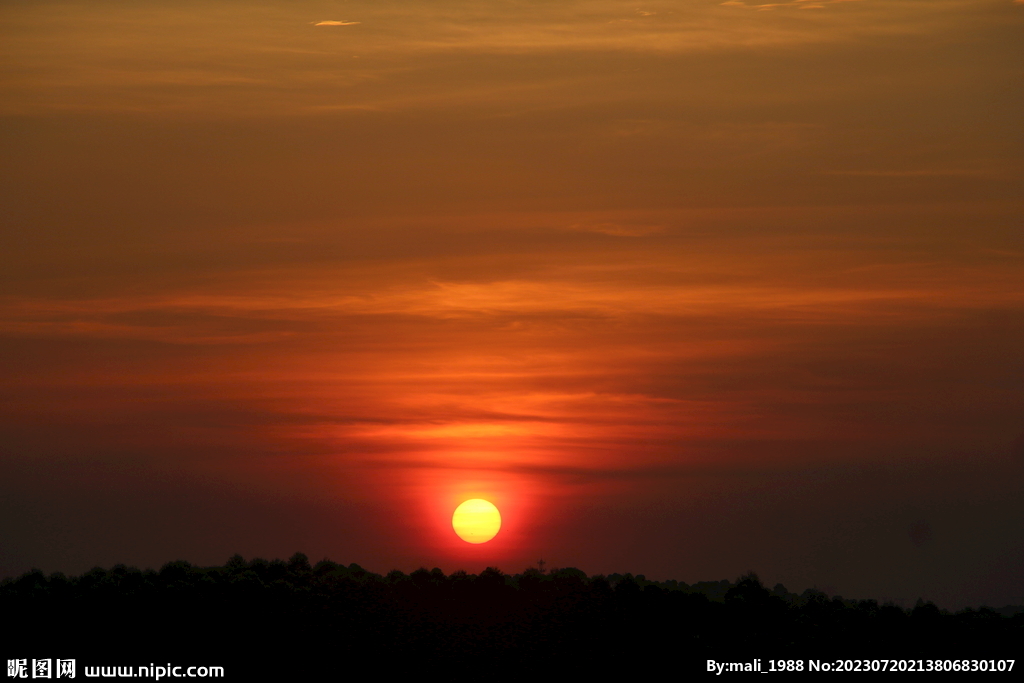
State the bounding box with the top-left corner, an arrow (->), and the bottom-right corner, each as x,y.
0,553 -> 1024,680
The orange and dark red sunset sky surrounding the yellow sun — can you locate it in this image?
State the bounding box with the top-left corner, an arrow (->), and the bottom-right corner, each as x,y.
0,0 -> 1024,608
